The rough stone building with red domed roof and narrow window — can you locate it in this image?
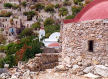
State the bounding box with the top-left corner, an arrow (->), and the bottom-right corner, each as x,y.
61,0 -> 108,66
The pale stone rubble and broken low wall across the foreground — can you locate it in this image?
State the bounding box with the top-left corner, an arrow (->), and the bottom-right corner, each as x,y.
0,53 -> 108,79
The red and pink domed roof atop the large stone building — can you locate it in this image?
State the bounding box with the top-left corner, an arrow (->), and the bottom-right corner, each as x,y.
64,0 -> 108,23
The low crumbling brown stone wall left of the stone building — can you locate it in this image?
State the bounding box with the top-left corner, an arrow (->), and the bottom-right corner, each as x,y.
24,53 -> 60,71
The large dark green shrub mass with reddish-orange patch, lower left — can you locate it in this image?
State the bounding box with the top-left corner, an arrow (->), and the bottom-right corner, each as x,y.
0,34 -> 43,68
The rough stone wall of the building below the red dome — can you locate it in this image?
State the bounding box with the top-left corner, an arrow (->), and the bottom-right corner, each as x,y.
62,19 -> 108,66
